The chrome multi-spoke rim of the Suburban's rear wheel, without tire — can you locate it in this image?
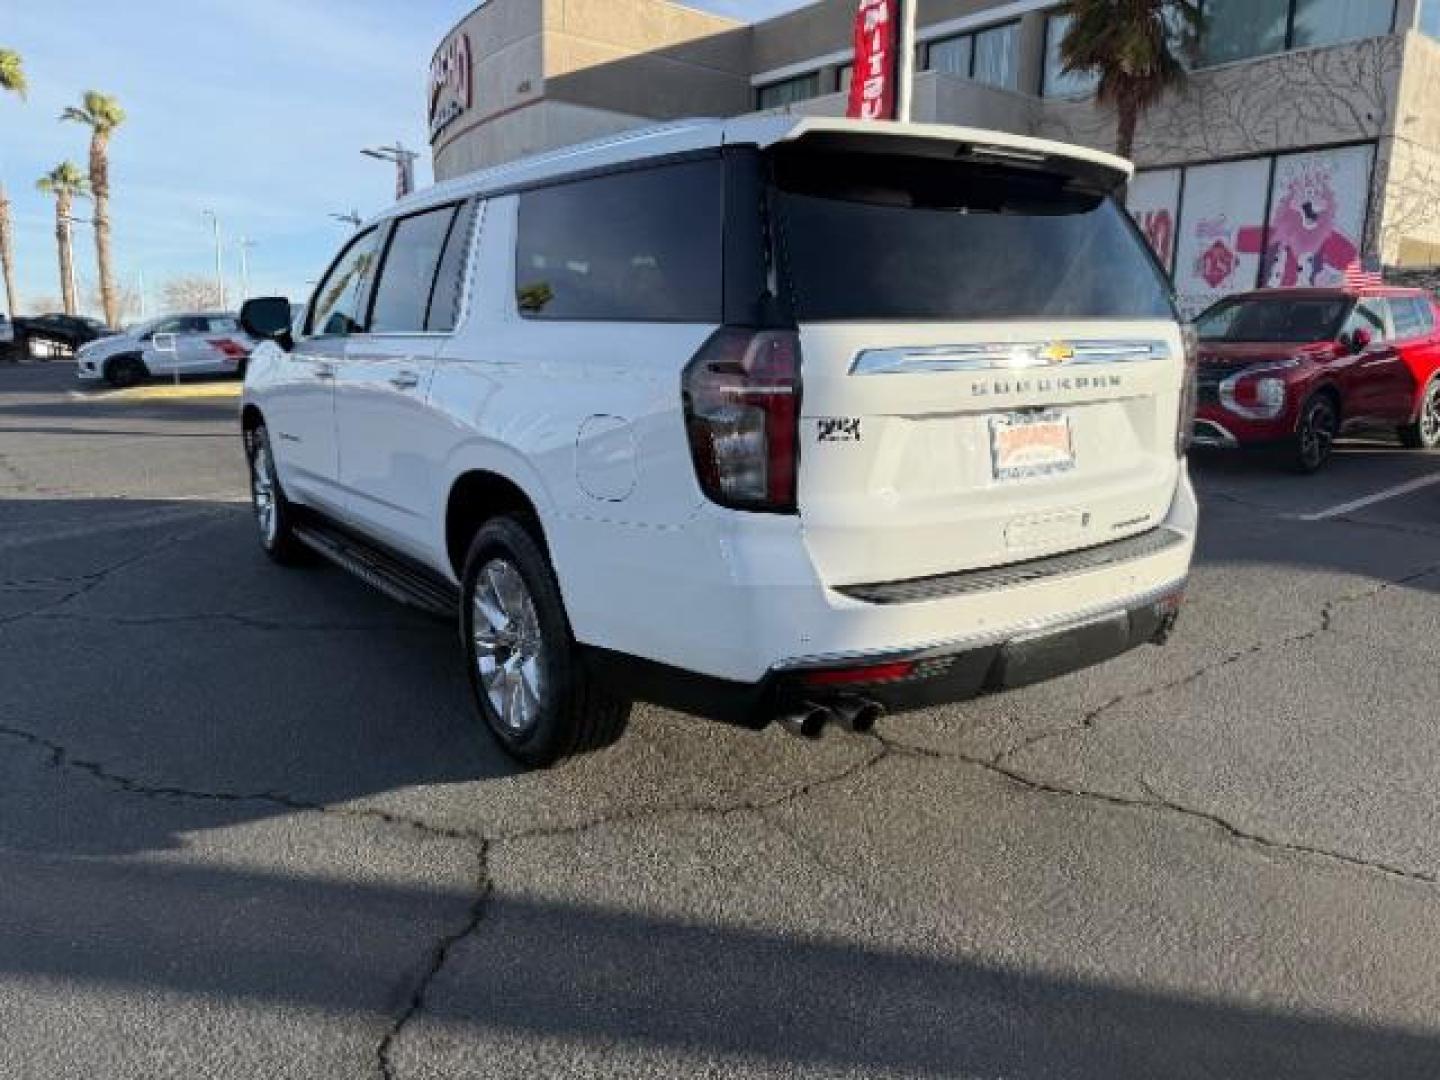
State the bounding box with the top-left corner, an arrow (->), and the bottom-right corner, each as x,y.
471,559 -> 544,734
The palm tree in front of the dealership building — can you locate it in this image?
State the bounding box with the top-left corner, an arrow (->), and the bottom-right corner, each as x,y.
1058,0 -> 1202,164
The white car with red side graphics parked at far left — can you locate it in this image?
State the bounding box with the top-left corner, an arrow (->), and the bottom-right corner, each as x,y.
75,311 -> 255,386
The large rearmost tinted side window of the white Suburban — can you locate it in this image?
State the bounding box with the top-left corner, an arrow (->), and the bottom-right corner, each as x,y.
516,158 -> 724,323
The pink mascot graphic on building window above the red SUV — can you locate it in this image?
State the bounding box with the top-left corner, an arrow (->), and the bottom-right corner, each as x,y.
1238,167 -> 1359,288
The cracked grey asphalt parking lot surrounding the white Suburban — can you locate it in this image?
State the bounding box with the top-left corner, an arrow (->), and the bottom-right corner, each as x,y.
0,363 -> 1440,1080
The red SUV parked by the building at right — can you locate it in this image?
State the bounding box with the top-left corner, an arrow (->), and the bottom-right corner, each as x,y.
1195,288 -> 1440,472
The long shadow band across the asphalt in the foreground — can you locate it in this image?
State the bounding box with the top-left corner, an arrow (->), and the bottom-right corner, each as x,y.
0,860 -> 1440,1080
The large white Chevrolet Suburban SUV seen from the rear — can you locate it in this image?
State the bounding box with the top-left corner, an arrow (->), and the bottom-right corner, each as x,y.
242,117 -> 1197,765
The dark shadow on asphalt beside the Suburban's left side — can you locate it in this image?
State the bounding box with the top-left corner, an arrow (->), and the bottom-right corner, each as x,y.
0,498 -> 518,855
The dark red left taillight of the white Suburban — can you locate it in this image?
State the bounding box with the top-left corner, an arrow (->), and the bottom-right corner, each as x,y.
683,328 -> 801,514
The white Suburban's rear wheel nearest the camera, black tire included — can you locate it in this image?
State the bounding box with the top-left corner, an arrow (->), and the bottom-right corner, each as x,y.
461,517 -> 631,768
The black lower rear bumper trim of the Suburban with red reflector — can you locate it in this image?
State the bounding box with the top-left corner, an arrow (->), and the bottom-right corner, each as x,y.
588,580 -> 1185,729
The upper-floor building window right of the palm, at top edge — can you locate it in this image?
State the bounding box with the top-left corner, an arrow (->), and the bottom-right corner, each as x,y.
1201,0 -> 1393,63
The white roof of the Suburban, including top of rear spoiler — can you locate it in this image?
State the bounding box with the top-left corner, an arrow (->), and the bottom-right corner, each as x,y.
376,114 -> 1135,226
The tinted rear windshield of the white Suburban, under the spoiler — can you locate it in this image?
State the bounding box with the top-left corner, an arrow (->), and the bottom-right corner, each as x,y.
772,151 -> 1175,321
